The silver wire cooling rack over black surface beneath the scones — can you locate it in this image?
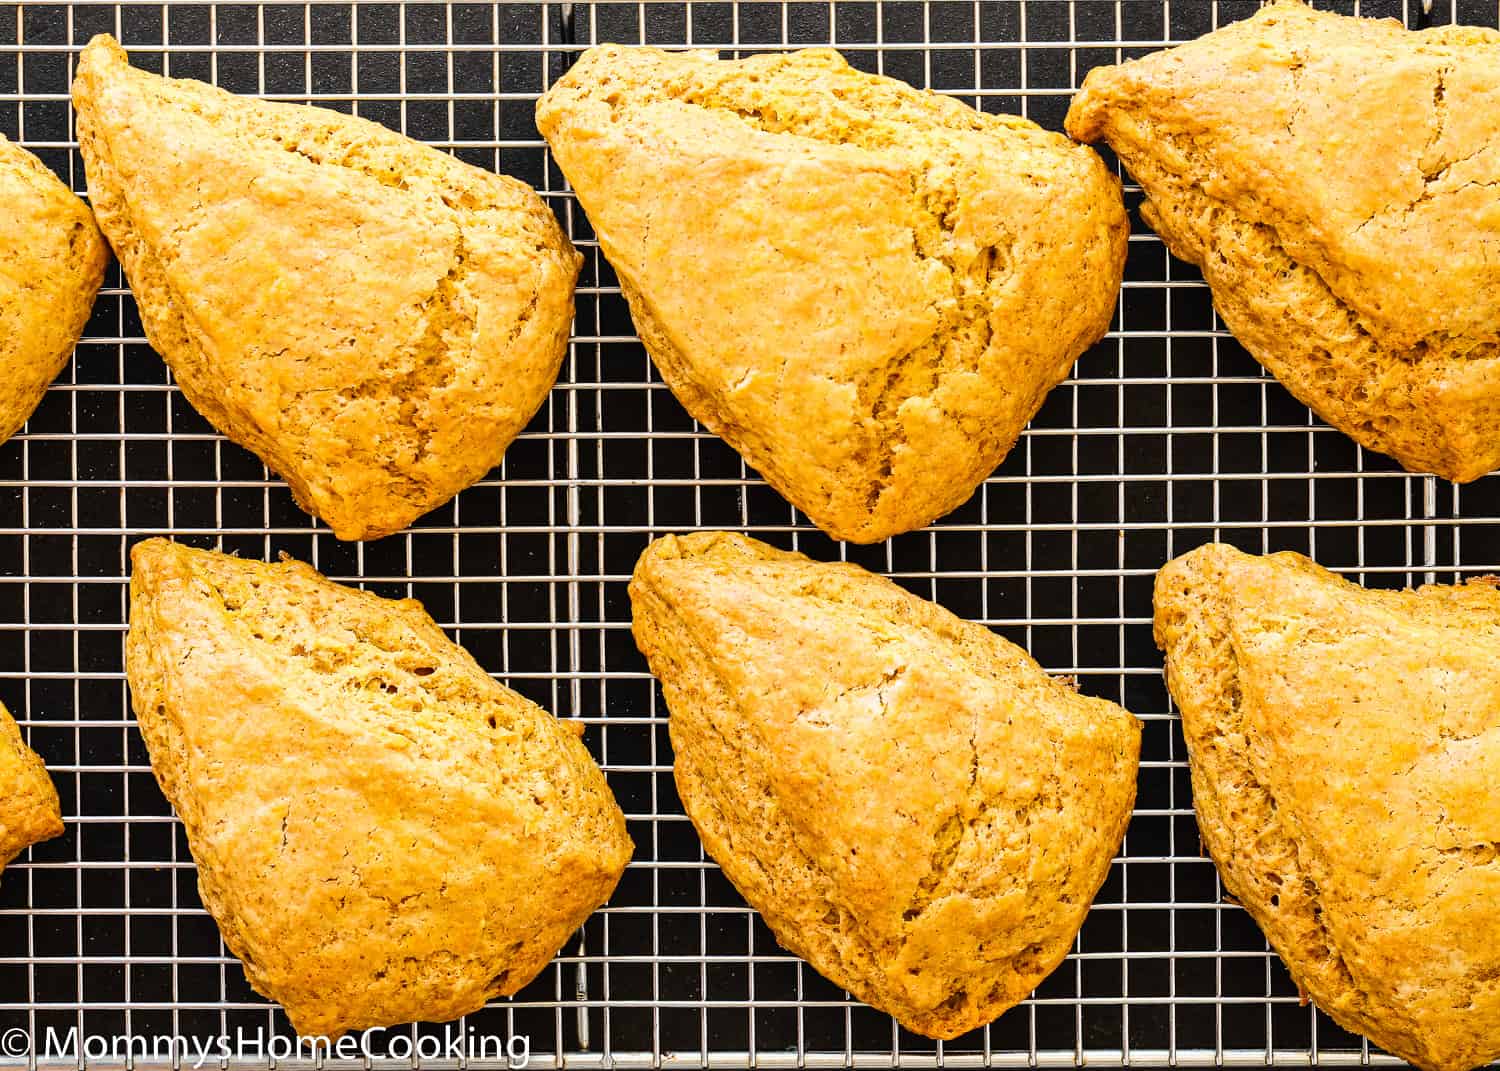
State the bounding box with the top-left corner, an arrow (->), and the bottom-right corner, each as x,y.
0,0 -> 1500,1067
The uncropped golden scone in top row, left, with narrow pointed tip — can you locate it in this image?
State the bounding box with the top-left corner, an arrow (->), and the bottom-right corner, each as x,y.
74,36 -> 581,540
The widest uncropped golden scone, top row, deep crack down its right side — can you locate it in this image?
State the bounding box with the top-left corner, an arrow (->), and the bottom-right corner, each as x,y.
537,45 -> 1128,543
